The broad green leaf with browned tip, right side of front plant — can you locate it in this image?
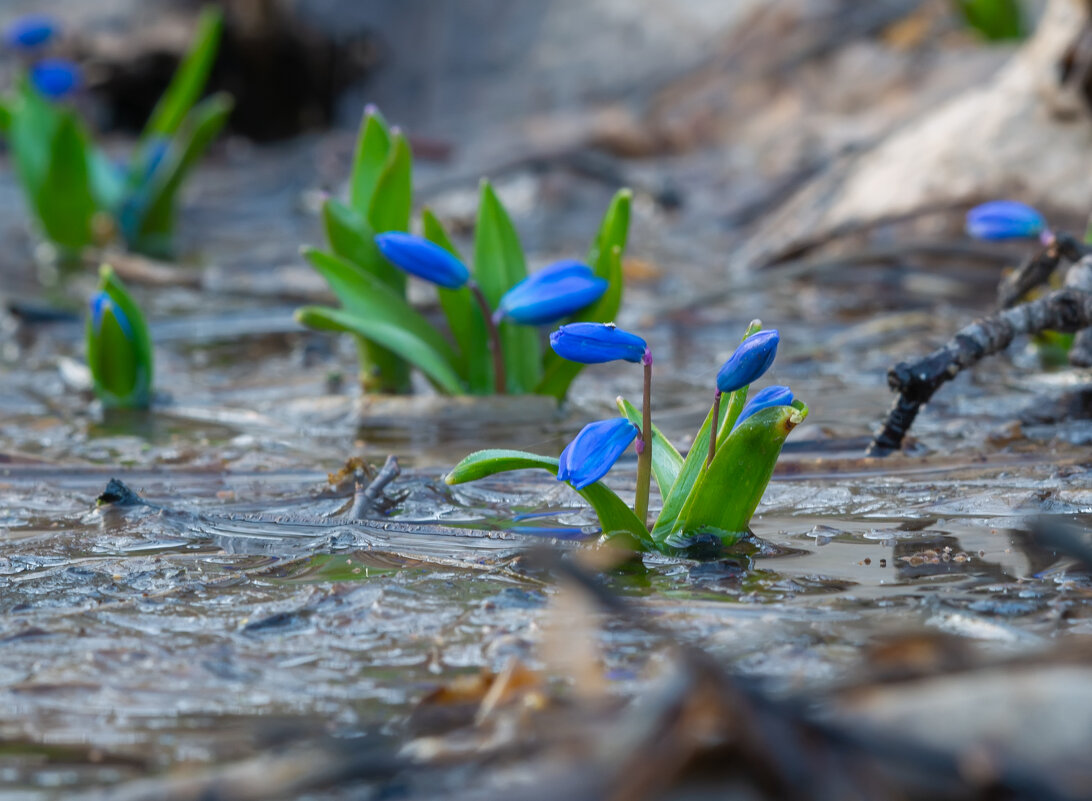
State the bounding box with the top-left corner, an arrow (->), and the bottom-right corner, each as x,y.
668,401 -> 808,543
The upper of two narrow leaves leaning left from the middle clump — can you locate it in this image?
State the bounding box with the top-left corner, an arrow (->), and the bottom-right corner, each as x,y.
302,248 -> 458,372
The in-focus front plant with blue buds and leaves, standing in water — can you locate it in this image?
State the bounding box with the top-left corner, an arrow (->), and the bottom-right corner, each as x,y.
444,321 -> 808,553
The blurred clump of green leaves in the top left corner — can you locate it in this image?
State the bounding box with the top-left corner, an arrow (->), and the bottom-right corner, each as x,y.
0,7 -> 232,256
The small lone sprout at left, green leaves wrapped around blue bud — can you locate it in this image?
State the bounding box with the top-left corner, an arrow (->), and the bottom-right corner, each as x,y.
86,266 -> 153,408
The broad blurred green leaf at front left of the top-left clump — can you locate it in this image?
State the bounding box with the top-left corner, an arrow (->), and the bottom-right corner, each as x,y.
34,111 -> 96,250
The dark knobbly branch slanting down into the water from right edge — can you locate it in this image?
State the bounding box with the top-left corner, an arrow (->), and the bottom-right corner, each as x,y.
868,288 -> 1092,456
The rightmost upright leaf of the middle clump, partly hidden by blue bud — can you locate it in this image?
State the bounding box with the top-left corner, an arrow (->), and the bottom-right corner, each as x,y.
535,189 -> 633,401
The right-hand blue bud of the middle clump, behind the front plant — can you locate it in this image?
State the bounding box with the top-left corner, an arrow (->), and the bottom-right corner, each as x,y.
497,260 -> 607,325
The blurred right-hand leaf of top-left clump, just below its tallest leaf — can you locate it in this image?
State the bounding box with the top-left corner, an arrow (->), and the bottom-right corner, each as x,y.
122,93 -> 233,255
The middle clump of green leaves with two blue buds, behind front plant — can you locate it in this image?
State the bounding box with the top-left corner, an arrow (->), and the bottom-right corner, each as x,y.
296,107 -> 631,401
